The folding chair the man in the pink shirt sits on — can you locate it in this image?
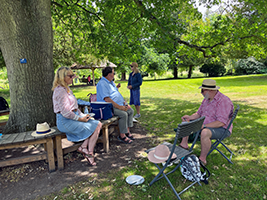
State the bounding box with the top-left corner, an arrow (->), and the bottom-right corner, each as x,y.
207,105 -> 240,164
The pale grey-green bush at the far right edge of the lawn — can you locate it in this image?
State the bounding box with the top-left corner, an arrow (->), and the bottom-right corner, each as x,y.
235,57 -> 267,74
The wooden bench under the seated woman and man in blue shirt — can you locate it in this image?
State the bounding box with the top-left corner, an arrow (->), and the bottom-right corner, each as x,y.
53,116 -> 119,170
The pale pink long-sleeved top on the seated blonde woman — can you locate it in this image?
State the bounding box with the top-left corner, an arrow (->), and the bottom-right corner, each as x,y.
53,86 -> 84,120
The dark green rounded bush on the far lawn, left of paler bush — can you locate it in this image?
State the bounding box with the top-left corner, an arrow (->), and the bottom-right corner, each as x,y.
200,63 -> 226,77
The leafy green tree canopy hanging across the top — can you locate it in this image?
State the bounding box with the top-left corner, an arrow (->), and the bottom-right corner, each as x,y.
52,0 -> 267,77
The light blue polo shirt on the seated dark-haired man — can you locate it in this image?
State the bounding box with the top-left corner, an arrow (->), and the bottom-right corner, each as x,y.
96,77 -> 124,106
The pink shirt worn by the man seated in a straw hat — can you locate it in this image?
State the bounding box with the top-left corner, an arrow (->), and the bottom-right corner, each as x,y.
197,91 -> 234,133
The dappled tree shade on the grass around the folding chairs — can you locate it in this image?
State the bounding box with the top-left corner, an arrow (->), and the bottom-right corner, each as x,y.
20,94 -> 267,199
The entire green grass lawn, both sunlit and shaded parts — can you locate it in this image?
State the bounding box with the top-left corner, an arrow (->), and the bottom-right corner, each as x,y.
2,75 -> 267,200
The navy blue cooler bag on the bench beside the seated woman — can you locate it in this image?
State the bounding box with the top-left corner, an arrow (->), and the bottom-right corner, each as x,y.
91,101 -> 113,120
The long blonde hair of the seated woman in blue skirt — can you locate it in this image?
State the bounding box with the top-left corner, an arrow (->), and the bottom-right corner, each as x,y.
52,67 -> 72,92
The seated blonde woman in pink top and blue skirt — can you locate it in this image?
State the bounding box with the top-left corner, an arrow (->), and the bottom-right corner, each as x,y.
52,67 -> 102,165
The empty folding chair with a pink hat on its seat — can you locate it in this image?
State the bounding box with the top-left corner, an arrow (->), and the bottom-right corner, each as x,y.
146,117 -> 205,199
